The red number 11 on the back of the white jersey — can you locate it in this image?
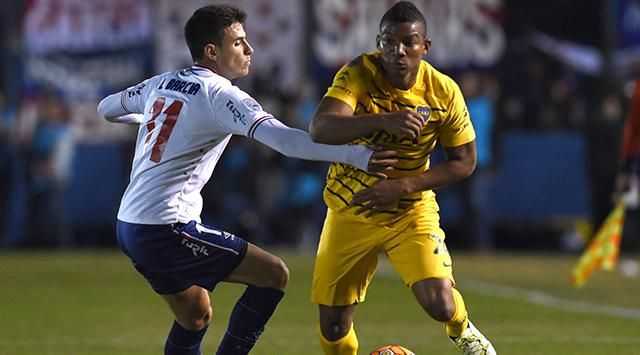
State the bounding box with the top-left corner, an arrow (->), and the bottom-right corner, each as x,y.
144,96 -> 183,163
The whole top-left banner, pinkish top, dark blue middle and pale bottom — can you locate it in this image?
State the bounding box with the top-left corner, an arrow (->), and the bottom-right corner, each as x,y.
23,0 -> 152,100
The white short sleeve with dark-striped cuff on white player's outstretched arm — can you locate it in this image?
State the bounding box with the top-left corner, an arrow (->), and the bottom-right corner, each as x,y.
213,86 -> 273,138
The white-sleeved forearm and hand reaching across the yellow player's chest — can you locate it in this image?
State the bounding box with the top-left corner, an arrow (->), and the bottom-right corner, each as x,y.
253,118 -> 398,175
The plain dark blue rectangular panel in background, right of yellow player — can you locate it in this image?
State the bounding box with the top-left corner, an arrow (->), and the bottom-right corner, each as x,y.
493,132 -> 590,222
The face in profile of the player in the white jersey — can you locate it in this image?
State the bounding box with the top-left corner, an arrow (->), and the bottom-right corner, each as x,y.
216,22 -> 253,79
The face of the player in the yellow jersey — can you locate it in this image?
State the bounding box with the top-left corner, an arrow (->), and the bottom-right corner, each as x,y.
378,22 -> 431,87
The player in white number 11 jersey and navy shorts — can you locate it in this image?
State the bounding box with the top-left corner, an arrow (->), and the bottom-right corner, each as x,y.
98,5 -> 397,355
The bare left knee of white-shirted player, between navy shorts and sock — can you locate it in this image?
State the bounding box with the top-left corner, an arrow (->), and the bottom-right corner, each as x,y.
161,286 -> 212,330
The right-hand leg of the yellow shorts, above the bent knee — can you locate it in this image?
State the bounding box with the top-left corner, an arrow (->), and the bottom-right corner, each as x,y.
384,228 -> 454,286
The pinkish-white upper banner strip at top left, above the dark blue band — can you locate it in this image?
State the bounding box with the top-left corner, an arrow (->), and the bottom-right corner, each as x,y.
23,0 -> 152,54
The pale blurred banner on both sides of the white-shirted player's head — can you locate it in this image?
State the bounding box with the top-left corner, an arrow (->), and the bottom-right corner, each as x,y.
154,0 -> 306,91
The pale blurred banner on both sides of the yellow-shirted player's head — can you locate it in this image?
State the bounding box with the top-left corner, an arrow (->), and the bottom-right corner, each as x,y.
311,0 -> 506,68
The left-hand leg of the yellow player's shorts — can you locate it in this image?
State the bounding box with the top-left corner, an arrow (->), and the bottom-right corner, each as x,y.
311,210 -> 389,306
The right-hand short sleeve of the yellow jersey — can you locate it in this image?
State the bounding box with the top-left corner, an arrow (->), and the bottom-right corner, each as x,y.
439,82 -> 476,147
